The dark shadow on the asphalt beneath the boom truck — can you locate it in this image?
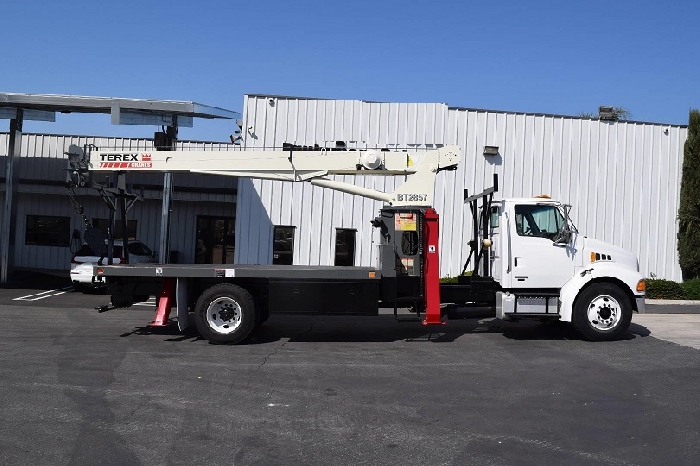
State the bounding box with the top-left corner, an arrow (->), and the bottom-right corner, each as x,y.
121,315 -> 650,345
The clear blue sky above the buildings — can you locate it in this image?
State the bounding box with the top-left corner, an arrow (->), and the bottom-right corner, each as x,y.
0,0 -> 700,141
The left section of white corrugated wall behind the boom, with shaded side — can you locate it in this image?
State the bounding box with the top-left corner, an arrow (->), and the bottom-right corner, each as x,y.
236,96 -> 448,265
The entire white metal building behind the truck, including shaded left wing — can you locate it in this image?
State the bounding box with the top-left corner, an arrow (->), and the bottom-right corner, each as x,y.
0,95 -> 687,280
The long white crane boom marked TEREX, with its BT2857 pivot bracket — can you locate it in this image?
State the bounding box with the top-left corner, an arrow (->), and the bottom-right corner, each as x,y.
87,146 -> 461,206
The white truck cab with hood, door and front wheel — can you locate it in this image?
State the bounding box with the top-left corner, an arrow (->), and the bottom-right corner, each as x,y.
482,196 -> 645,340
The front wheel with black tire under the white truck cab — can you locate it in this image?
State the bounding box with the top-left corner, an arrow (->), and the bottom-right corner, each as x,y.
573,283 -> 632,341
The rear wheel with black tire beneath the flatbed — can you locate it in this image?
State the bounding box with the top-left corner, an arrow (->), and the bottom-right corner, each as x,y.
194,283 -> 256,345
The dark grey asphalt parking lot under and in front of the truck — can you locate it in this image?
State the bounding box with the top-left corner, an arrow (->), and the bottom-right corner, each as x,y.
0,274 -> 700,465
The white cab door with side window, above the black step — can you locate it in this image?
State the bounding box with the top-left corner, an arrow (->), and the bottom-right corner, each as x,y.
503,203 -> 576,289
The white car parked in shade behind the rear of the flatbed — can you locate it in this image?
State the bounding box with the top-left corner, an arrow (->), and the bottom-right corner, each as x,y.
70,239 -> 158,291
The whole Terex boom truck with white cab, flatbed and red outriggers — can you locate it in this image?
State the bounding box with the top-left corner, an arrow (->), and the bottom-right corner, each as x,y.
68,145 -> 645,344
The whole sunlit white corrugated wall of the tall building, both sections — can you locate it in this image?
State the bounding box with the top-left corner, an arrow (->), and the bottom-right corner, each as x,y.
236,96 -> 687,280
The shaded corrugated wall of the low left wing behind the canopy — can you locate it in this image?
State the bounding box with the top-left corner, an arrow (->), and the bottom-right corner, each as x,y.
0,133 -> 238,270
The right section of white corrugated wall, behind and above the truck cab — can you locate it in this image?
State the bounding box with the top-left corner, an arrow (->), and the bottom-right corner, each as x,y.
439,109 -> 687,280
